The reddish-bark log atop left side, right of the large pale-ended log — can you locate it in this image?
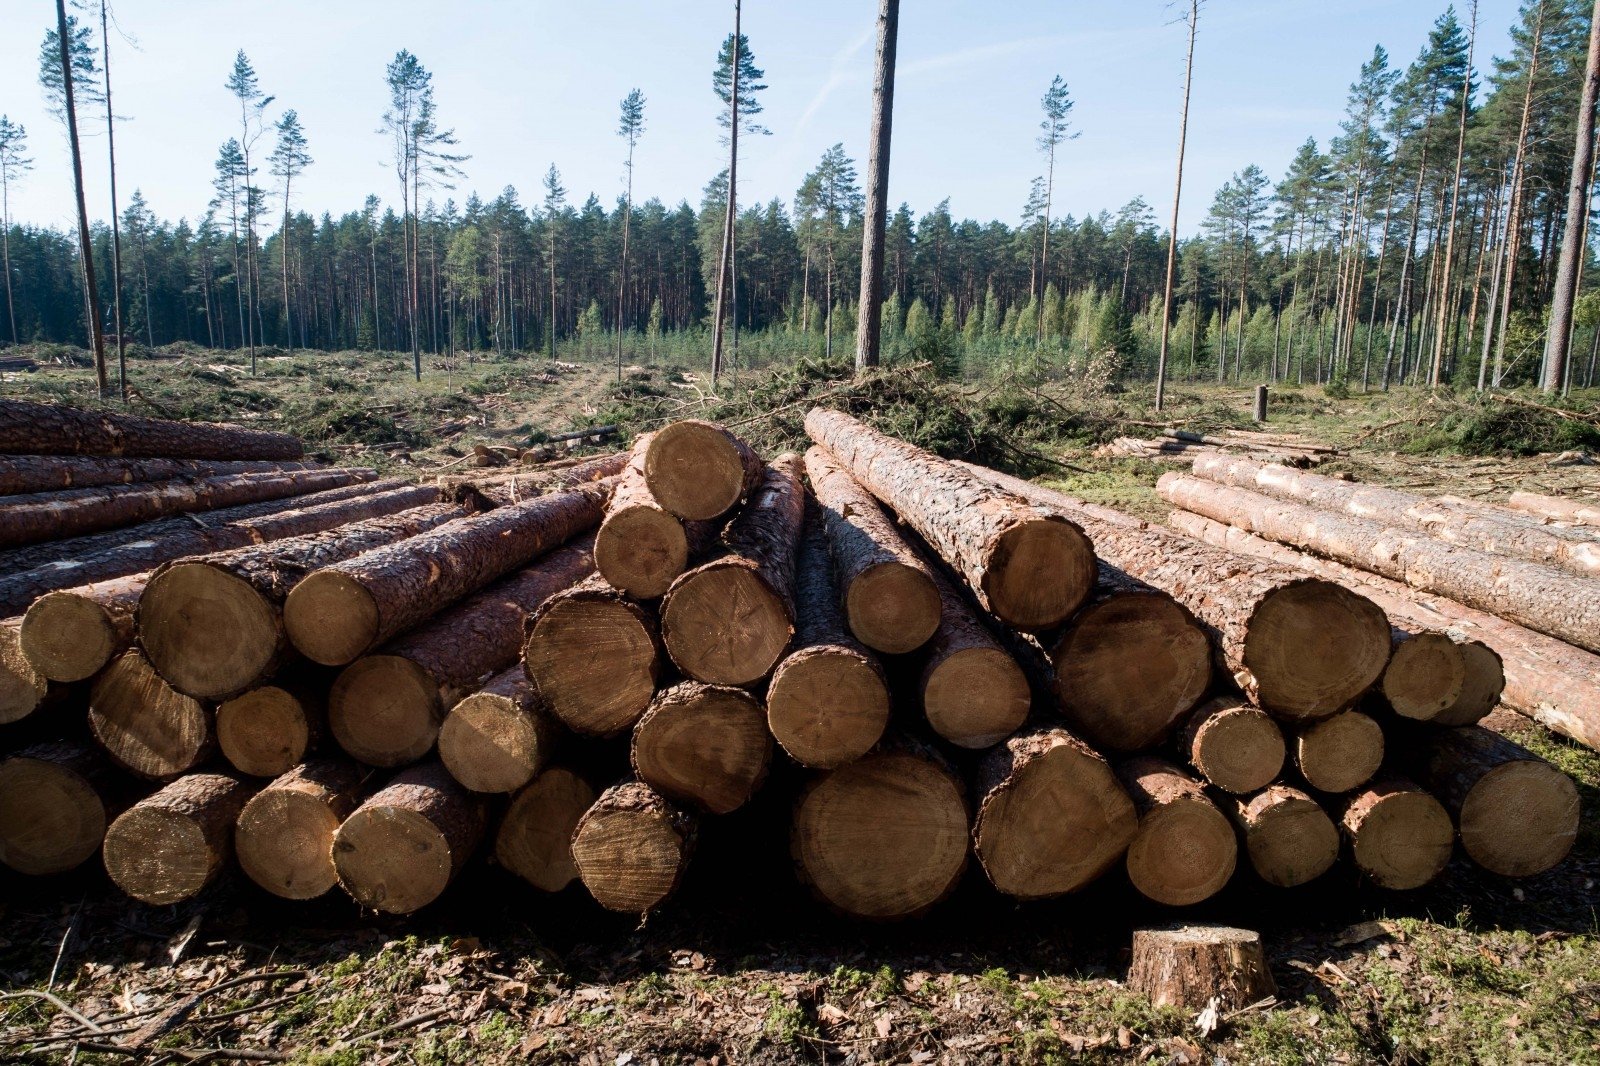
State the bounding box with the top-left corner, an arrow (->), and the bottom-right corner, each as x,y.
283,482 -> 610,666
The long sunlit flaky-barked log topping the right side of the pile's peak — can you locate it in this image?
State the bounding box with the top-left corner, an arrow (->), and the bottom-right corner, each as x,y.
805,408 -> 1098,629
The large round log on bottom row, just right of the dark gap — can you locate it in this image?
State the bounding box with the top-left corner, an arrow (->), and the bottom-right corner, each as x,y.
789,736 -> 970,920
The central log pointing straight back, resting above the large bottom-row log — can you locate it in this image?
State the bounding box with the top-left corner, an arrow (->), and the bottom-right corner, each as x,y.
766,505 -> 896,770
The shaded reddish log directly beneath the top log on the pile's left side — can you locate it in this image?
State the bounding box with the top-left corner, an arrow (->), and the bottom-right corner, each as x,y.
328,541 -> 594,767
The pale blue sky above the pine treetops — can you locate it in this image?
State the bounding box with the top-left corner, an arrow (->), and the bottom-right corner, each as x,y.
0,0 -> 1515,232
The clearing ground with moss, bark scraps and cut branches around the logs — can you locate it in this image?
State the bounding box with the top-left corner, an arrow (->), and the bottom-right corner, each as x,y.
0,349 -> 1600,1066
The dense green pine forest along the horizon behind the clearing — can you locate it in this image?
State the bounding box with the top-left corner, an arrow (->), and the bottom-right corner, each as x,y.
0,0 -> 1600,387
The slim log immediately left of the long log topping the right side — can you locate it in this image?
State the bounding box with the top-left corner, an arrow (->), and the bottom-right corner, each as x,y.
805,447 -> 939,655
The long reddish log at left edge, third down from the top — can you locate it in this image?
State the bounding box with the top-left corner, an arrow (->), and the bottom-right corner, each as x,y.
0,469 -> 378,547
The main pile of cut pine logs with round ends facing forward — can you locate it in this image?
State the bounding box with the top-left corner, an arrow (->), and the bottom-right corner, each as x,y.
0,393 -> 1592,919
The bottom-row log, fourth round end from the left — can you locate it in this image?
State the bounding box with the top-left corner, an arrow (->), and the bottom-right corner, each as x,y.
333,762 -> 485,914
